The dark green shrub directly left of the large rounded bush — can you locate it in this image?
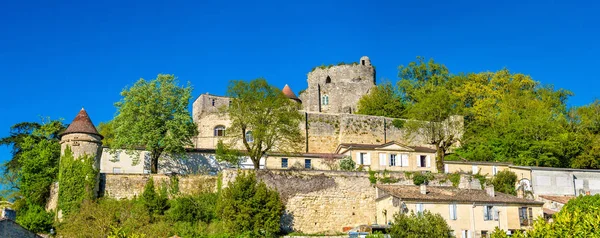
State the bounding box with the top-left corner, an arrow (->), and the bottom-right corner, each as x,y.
166,193 -> 218,223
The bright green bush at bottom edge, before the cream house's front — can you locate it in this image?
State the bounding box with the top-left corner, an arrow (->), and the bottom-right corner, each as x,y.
389,210 -> 453,238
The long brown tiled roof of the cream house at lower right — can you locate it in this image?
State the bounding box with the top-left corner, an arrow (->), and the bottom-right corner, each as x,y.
377,185 -> 544,206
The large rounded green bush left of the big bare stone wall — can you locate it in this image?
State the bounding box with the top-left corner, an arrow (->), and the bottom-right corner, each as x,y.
217,172 -> 284,237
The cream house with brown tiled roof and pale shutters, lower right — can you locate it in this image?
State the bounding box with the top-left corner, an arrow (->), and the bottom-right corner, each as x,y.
376,185 -> 543,238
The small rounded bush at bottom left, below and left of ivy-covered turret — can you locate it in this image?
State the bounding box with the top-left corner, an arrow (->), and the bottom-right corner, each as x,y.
17,205 -> 54,233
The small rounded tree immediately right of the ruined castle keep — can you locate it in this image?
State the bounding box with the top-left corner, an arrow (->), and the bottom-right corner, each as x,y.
356,82 -> 405,118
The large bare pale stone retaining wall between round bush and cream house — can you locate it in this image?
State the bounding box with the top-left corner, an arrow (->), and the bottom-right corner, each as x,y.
223,169 -> 452,234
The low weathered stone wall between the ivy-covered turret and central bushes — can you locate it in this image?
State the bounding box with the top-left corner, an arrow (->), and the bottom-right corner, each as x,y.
99,174 -> 217,199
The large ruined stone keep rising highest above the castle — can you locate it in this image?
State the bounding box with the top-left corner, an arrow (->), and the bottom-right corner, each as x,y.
300,56 -> 376,113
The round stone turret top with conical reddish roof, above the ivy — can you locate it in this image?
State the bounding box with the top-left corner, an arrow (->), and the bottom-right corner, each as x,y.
59,108 -> 103,170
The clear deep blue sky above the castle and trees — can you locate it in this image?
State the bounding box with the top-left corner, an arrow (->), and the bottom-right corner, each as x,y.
0,0 -> 600,164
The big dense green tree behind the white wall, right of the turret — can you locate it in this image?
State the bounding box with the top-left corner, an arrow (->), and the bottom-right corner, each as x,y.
112,74 -> 198,173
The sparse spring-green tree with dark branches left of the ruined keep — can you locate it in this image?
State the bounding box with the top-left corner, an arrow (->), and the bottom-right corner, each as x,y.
222,78 -> 303,169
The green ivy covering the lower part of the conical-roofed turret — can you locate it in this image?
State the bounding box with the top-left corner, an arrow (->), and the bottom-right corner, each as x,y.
58,146 -> 98,215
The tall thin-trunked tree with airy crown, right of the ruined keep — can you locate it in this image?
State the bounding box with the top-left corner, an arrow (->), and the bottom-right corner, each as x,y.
398,57 -> 463,171
